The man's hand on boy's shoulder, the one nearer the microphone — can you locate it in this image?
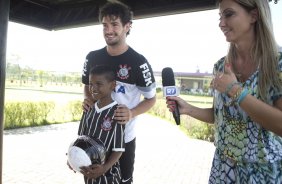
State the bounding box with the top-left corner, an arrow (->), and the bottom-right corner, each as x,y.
114,104 -> 132,125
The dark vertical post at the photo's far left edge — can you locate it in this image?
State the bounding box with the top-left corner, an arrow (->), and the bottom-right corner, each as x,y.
0,0 -> 10,184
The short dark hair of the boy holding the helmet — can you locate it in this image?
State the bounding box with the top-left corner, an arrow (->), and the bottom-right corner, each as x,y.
90,65 -> 116,82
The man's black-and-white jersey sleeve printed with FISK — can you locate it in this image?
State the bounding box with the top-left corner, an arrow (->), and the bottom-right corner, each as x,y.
136,57 -> 156,98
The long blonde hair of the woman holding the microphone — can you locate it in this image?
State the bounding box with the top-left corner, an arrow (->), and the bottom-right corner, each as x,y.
219,0 -> 282,101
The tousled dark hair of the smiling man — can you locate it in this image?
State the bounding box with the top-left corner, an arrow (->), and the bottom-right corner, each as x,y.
99,1 -> 133,35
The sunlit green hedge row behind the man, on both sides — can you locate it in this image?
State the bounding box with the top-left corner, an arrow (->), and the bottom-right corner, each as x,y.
4,98 -> 214,141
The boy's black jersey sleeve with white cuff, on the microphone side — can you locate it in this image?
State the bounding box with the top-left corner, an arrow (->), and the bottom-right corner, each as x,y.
112,123 -> 125,152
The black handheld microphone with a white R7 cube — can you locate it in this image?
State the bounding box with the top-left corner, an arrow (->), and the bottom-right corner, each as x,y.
162,67 -> 180,125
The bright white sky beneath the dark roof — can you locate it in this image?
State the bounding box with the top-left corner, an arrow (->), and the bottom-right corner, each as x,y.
7,1 -> 282,73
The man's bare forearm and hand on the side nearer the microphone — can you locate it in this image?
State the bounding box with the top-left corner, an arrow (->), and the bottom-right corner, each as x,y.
114,96 -> 156,124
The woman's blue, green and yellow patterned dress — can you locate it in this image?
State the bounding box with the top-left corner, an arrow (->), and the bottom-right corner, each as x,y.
209,53 -> 282,184
